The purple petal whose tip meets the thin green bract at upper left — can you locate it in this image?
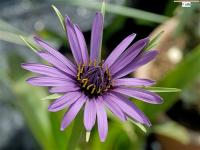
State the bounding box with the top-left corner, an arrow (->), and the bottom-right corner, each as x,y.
37,51 -> 76,77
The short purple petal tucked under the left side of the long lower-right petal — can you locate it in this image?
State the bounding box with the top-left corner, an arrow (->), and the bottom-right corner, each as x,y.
103,96 -> 126,121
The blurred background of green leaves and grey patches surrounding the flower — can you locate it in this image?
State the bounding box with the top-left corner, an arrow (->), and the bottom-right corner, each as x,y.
0,0 -> 200,150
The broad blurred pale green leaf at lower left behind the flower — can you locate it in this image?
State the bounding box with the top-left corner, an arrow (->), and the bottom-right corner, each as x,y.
12,78 -> 57,150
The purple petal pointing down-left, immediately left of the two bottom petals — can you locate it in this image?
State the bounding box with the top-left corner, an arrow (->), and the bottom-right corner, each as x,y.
60,95 -> 87,131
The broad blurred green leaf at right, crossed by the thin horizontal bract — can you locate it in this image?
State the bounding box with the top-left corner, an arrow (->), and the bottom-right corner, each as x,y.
142,45 -> 200,120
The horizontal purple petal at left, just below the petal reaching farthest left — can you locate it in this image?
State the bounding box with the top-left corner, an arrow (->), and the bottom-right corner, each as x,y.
26,76 -> 72,86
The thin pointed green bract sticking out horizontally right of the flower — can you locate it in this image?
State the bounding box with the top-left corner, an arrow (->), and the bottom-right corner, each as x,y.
144,87 -> 181,93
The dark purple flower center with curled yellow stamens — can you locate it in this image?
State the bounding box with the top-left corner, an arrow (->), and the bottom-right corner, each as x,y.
77,62 -> 112,98
